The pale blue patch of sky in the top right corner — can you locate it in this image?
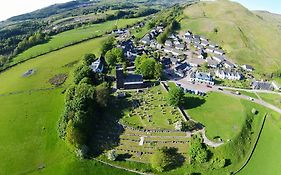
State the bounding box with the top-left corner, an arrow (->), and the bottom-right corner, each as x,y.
232,0 -> 281,14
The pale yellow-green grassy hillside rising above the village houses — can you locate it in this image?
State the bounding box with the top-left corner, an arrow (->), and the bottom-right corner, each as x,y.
181,0 -> 281,73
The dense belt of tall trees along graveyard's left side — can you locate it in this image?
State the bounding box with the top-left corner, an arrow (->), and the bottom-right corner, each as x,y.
58,54 -> 110,157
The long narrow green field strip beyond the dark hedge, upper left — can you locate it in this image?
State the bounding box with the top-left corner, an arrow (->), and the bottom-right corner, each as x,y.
10,17 -> 144,65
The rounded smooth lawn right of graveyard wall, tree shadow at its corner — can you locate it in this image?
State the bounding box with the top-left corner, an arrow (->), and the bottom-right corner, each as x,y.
184,92 -> 246,141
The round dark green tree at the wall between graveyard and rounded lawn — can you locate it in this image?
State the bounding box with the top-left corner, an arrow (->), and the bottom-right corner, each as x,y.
169,87 -> 184,107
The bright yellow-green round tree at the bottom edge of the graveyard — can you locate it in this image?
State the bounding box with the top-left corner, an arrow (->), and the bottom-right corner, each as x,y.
150,147 -> 174,172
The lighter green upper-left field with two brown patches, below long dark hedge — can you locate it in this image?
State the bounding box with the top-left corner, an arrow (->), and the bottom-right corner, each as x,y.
0,38 -> 105,94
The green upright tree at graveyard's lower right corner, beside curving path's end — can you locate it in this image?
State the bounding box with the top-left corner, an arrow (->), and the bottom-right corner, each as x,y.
189,134 -> 208,163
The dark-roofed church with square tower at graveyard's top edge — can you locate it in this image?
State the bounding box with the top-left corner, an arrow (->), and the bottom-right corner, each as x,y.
116,65 -> 144,89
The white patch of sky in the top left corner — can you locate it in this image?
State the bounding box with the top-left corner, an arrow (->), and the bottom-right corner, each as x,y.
0,0 -> 70,21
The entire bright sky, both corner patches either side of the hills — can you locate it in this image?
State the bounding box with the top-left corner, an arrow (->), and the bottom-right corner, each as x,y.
0,0 -> 281,21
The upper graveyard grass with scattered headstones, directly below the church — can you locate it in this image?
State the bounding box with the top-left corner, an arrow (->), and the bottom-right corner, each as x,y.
118,86 -> 183,129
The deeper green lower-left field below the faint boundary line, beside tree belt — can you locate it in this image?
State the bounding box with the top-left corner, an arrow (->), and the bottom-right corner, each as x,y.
0,89 -> 131,175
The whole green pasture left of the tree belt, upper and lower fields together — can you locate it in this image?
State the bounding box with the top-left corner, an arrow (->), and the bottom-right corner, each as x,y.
0,34 -> 135,175
